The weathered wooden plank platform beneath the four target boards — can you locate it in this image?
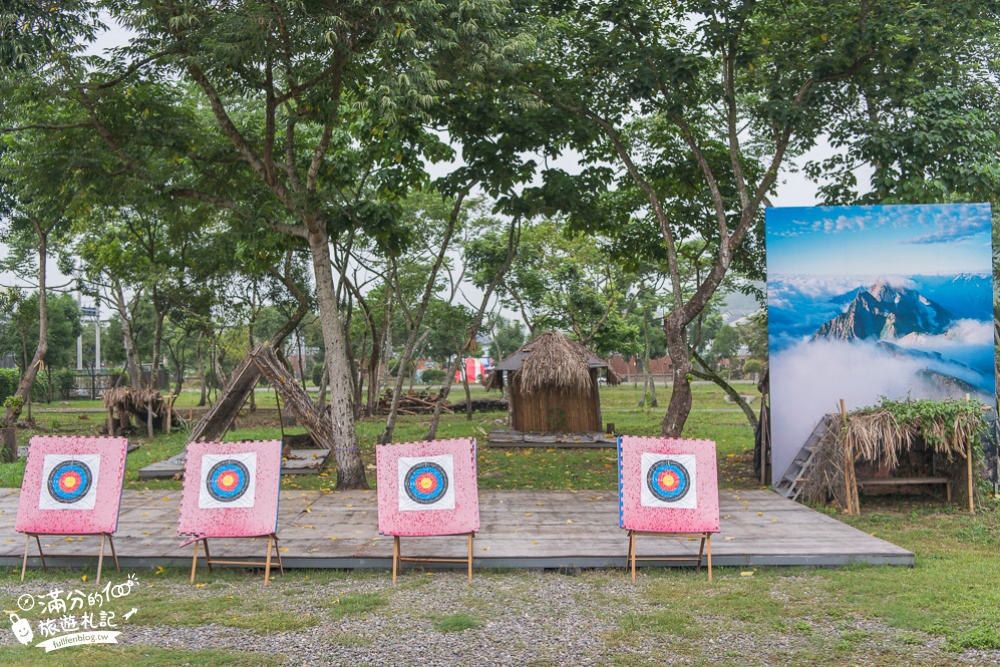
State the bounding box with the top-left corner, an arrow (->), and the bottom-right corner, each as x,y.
0,489 -> 913,568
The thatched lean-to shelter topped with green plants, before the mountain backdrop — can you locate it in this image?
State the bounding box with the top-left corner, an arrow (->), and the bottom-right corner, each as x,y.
802,399 -> 986,513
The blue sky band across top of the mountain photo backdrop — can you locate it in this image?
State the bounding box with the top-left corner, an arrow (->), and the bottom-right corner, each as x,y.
766,204 -> 992,276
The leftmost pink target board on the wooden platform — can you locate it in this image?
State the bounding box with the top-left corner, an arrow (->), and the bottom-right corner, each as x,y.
15,436 -> 128,535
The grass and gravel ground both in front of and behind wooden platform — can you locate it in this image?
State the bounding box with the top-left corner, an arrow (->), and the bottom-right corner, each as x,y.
0,384 -> 1000,667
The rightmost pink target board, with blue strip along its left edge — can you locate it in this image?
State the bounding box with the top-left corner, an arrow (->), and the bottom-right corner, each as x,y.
618,436 -> 719,533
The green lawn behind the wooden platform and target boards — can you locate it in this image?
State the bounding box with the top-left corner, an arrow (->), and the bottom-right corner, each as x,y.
0,383 -> 757,491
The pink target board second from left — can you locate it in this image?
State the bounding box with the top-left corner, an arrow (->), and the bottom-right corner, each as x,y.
177,440 -> 281,537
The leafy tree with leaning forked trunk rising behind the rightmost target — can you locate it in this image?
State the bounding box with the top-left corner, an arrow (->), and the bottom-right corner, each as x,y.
498,0 -> 996,436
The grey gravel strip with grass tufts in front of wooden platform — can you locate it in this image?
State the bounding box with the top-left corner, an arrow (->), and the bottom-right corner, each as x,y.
0,570 -> 1000,667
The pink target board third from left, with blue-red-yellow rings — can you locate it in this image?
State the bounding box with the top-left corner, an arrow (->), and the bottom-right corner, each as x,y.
375,439 -> 479,537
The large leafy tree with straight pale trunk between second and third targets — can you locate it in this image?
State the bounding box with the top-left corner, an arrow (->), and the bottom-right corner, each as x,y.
6,0 -> 532,488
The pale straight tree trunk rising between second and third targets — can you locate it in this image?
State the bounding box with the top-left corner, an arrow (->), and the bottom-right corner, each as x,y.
309,230 -> 368,489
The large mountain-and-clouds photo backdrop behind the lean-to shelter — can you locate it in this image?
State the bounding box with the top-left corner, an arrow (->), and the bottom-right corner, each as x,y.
766,204 -> 996,482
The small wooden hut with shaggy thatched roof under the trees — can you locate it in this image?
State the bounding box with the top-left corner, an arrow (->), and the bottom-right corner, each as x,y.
486,331 -> 621,433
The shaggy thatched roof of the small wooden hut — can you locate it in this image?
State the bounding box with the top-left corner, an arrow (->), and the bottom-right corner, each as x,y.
486,331 -> 621,394
